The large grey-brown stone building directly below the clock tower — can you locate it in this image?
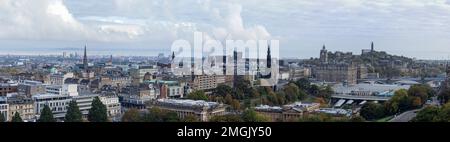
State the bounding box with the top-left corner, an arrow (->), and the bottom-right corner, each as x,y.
314,63 -> 357,84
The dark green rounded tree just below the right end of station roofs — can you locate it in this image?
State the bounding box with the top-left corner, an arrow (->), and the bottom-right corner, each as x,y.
360,103 -> 384,120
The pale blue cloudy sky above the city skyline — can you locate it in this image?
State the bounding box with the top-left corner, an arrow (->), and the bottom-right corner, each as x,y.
0,0 -> 450,59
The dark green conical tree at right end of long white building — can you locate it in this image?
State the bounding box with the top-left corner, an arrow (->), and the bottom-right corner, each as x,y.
88,97 -> 108,122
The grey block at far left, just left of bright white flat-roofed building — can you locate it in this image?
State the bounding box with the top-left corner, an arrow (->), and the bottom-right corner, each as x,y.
17,80 -> 45,97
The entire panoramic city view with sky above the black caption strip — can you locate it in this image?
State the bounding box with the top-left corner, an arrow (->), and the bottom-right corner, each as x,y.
0,0 -> 450,122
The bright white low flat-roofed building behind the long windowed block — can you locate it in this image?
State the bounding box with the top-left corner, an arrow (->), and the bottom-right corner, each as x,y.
45,84 -> 78,96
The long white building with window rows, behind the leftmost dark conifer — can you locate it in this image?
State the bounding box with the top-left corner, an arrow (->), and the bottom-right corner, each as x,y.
32,94 -> 72,120
